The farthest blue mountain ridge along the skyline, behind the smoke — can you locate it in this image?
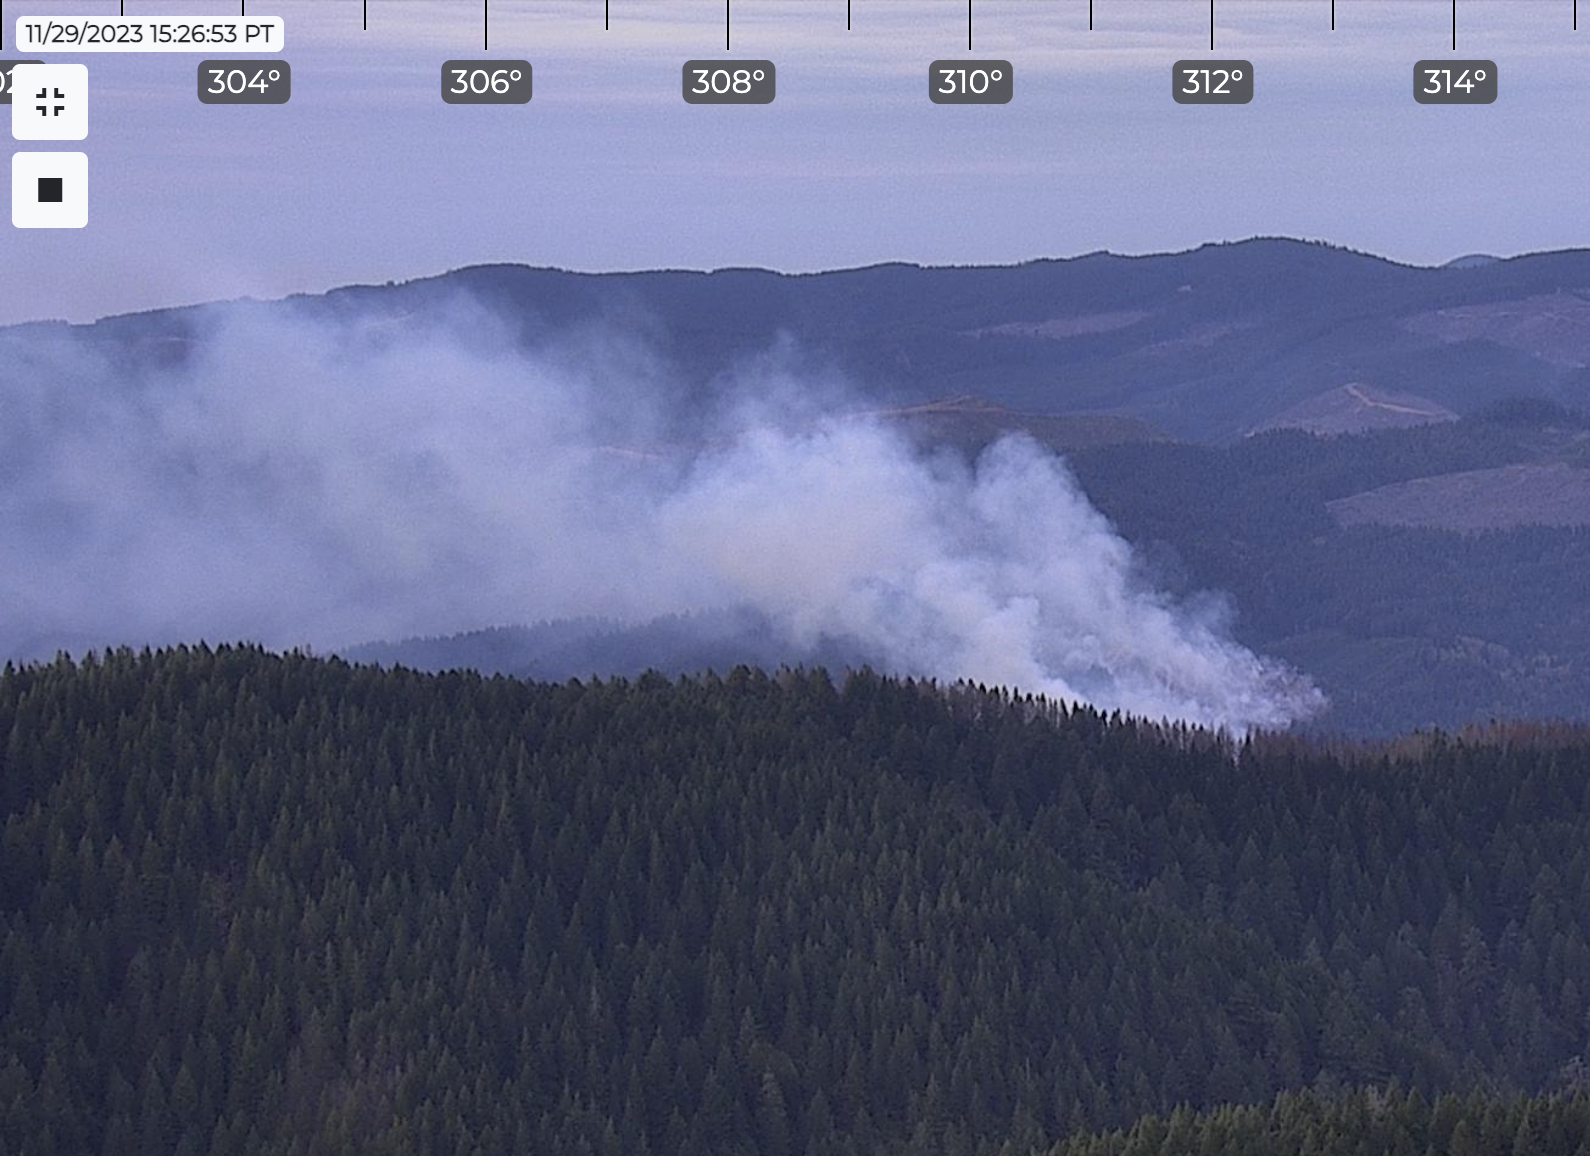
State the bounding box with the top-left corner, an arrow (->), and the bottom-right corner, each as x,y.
18,239 -> 1590,440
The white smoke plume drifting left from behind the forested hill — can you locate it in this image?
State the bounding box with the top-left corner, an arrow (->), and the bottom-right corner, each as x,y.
0,298 -> 1323,728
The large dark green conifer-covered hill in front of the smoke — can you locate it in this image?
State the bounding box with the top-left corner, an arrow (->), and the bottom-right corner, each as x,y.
0,647 -> 1590,1156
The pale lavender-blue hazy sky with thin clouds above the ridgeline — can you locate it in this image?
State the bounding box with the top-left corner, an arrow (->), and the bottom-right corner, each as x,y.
9,0 -> 1590,321
